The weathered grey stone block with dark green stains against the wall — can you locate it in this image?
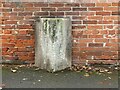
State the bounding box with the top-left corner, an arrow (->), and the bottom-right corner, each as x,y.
35,18 -> 71,72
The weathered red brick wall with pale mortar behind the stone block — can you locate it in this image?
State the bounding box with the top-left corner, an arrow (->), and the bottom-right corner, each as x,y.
0,2 -> 119,63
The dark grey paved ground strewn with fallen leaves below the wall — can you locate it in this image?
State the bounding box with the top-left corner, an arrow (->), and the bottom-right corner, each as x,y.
2,65 -> 120,88
